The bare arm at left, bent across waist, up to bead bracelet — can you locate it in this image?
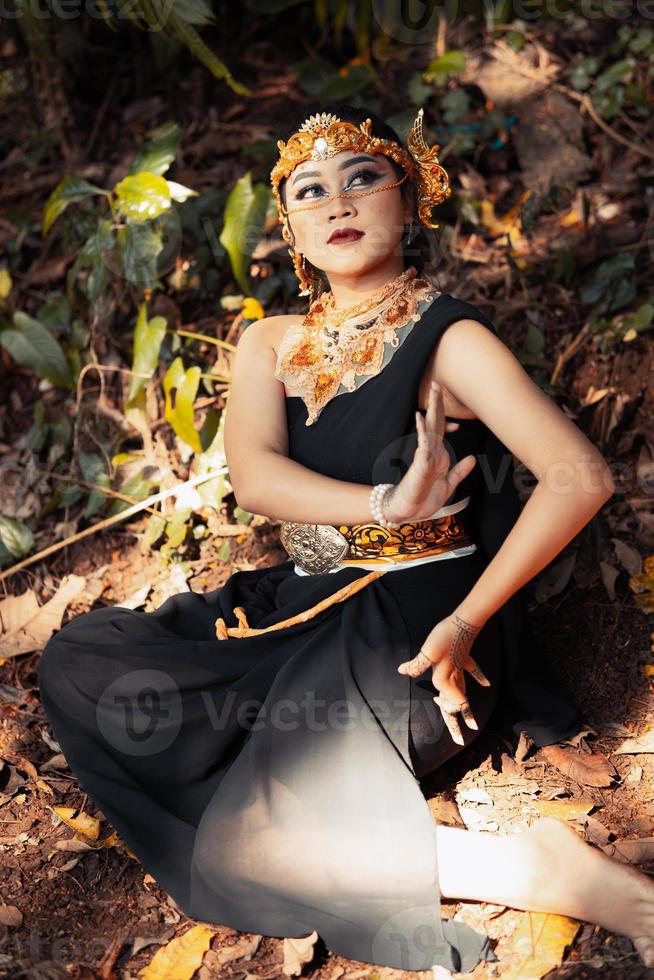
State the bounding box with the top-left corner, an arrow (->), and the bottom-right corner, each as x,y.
225,317 -> 392,524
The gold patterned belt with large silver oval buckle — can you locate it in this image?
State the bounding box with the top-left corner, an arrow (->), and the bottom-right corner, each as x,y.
280,497 -> 473,575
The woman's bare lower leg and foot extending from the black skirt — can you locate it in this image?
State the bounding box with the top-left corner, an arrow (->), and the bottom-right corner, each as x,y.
436,817 -> 654,966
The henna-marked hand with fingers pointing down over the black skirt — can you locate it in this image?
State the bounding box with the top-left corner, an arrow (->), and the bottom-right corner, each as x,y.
397,613 -> 491,745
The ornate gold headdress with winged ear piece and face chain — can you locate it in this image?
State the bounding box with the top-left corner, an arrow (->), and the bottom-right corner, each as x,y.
270,108 -> 452,301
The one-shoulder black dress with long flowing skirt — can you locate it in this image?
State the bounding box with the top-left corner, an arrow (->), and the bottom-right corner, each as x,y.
38,294 -> 580,971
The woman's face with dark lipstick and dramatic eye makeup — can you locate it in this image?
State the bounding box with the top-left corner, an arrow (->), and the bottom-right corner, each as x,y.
282,150 -> 412,277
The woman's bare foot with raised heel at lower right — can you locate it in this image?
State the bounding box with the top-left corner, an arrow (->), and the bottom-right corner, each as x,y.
525,817 -> 654,967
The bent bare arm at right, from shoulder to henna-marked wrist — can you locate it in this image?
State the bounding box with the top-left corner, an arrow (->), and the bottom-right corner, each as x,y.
437,320 -> 615,627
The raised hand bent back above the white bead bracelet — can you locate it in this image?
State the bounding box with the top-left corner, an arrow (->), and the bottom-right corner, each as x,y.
384,381 -> 477,523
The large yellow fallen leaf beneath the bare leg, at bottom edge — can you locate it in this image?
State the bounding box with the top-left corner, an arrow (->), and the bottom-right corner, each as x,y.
499,912 -> 581,980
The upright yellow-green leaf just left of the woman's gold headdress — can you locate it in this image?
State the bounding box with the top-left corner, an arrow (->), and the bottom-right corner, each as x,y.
219,171 -> 270,295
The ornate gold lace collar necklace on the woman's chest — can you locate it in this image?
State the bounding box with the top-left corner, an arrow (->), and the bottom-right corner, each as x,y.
275,266 -> 436,425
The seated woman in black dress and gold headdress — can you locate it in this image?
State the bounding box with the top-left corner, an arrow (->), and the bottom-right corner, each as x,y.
39,106 -> 654,971
